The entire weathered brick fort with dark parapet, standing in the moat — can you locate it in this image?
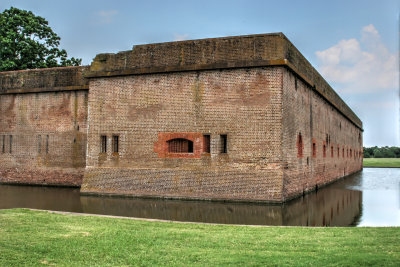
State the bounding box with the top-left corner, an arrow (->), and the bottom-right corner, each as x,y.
0,33 -> 362,202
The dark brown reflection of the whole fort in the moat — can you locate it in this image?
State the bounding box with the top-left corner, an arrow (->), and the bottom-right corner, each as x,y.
0,182 -> 362,226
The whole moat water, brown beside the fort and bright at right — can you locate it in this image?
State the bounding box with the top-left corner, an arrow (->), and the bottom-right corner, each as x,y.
0,168 -> 400,226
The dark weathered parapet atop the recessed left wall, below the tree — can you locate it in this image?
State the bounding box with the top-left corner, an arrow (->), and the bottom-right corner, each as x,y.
0,66 -> 89,94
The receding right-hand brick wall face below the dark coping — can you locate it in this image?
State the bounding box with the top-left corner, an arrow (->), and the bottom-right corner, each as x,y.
282,70 -> 362,199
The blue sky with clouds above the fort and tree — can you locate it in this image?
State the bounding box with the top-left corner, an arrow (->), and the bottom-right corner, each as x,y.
0,0 -> 400,146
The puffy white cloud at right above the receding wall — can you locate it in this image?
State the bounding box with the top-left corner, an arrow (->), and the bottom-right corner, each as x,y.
316,24 -> 399,93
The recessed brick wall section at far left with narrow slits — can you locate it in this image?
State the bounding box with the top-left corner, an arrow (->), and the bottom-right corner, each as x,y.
0,68 -> 88,186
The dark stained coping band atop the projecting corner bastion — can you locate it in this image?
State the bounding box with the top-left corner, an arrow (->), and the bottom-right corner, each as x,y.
85,33 -> 362,130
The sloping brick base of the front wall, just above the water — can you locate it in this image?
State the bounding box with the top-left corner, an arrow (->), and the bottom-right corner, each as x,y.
81,169 -> 282,202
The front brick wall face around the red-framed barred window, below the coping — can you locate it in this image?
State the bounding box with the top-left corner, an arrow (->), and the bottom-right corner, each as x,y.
82,67 -> 284,201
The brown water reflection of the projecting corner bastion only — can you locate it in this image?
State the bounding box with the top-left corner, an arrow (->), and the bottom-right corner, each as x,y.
81,188 -> 362,226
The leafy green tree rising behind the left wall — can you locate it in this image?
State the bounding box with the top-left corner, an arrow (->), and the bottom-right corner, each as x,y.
0,7 -> 82,71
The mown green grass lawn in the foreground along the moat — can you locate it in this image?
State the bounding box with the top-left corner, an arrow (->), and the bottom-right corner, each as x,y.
0,209 -> 400,266
